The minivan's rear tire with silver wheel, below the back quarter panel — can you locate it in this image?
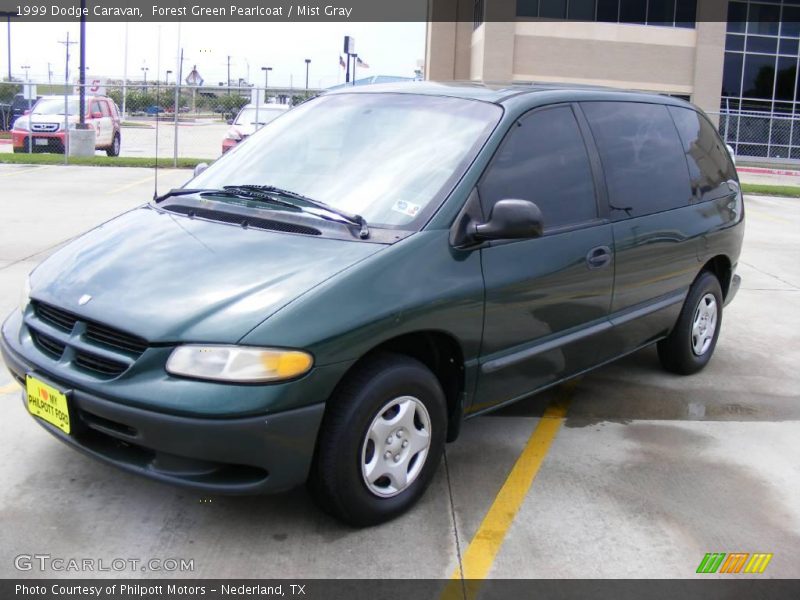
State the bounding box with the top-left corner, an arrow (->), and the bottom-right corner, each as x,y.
658,271 -> 722,375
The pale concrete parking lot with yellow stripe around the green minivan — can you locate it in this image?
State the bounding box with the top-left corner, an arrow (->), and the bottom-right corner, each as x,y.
0,165 -> 800,578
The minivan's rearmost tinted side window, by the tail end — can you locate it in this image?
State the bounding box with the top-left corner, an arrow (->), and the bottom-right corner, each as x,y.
669,106 -> 736,202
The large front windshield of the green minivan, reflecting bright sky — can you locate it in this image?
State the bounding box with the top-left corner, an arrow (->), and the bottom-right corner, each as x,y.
187,93 -> 502,229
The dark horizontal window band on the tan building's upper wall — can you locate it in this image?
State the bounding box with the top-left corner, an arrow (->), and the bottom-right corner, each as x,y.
517,0 -> 697,27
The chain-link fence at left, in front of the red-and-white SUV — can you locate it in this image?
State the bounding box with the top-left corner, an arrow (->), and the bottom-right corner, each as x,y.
0,81 -> 318,166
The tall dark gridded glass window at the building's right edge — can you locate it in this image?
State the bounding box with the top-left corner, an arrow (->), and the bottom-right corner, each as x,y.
720,0 -> 800,159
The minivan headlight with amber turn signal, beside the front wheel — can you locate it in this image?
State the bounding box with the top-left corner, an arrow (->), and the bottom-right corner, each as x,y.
167,345 -> 314,383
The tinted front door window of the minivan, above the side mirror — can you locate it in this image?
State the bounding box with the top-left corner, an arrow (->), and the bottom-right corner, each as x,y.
478,106 -> 597,229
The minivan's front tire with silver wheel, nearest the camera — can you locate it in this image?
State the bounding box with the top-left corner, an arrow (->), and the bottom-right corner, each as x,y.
308,354 -> 447,527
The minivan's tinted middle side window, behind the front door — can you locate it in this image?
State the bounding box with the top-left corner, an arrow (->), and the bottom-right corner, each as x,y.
582,102 -> 691,221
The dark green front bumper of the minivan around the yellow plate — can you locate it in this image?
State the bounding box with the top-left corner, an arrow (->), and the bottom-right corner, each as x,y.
0,316 -> 324,494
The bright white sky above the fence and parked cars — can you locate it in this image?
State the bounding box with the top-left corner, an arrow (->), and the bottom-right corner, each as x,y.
0,20 -> 425,87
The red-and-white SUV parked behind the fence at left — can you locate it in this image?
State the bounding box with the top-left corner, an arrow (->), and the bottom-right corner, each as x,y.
11,96 -> 122,156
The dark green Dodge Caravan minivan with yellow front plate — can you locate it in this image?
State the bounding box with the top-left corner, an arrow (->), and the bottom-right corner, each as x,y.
2,83 -> 744,525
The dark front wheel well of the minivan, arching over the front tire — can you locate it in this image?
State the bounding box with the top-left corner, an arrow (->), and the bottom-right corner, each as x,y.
356,331 -> 464,442
